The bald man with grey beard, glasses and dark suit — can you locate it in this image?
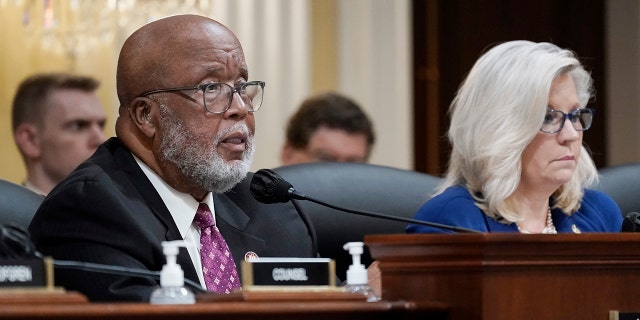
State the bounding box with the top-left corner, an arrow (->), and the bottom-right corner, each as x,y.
29,15 -> 316,301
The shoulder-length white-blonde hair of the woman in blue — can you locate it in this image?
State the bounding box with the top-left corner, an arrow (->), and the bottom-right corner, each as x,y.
437,40 -> 598,222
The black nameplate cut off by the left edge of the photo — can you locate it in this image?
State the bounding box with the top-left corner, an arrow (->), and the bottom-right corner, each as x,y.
0,259 -> 47,288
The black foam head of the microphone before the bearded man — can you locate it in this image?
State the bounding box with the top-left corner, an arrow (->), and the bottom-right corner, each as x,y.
249,169 -> 293,203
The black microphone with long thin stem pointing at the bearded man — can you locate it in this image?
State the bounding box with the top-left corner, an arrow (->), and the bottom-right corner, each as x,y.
250,169 -> 481,233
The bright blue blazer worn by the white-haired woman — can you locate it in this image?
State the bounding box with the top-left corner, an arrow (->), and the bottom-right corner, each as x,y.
406,186 -> 623,233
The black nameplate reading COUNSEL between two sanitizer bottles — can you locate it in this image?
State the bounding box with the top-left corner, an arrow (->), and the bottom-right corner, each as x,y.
242,258 -> 335,288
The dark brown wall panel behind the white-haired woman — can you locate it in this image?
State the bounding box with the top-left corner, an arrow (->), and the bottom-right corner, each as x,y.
413,0 -> 607,174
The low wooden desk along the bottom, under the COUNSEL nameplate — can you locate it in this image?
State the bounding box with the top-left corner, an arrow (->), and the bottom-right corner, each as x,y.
0,292 -> 448,320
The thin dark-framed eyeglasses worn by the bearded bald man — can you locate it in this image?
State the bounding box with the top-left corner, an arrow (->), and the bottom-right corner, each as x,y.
140,81 -> 265,114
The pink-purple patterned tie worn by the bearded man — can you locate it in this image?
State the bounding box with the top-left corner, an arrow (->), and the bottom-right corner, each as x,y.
195,203 -> 240,293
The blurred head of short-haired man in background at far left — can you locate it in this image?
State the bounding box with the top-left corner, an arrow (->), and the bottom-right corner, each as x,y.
12,73 -> 106,195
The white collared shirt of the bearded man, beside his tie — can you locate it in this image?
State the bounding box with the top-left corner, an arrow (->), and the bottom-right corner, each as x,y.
132,154 -> 215,239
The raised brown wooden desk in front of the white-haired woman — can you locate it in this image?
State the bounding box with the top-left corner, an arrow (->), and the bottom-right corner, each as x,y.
365,233 -> 640,320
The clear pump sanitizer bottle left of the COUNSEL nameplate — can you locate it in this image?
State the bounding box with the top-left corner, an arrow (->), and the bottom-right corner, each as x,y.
149,240 -> 196,304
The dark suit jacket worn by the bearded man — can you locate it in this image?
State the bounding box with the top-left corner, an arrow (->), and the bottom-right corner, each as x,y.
29,138 -> 316,301
